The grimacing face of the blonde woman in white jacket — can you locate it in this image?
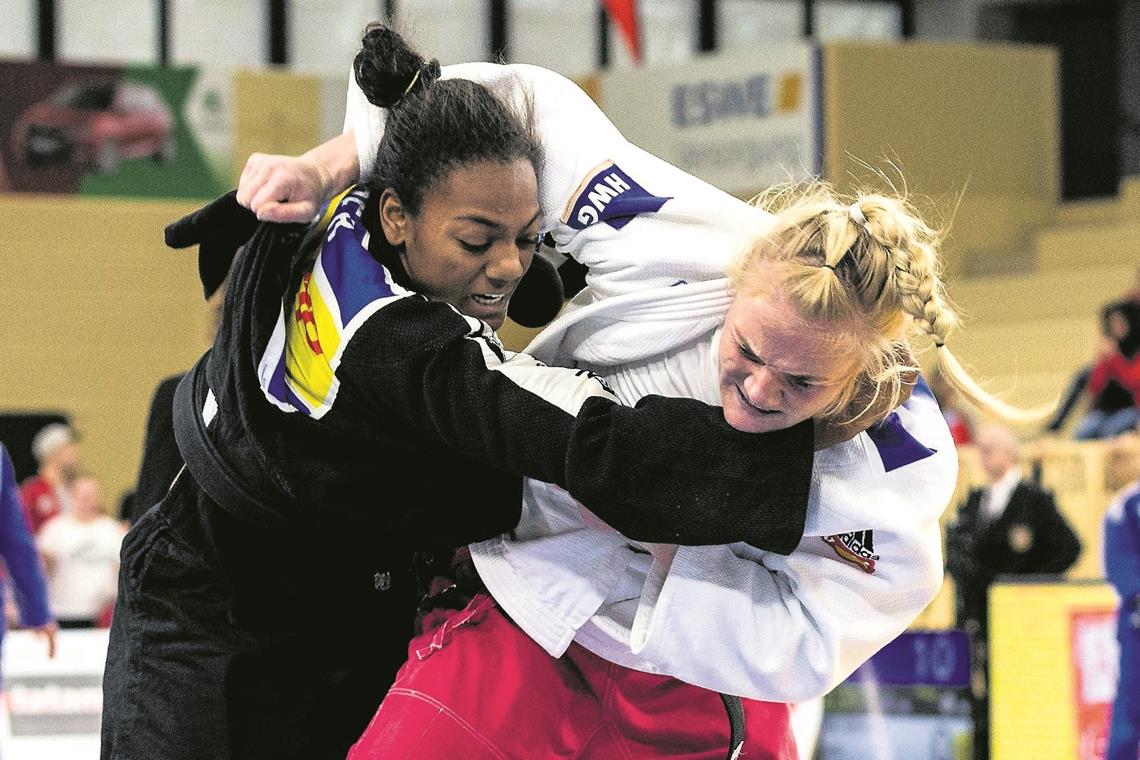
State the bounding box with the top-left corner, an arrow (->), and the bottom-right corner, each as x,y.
718,295 -> 855,433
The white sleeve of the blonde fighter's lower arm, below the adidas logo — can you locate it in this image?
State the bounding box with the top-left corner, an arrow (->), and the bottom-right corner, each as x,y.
630,523 -> 942,702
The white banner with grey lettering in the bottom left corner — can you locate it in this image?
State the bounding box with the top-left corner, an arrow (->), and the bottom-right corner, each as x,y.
0,630 -> 107,760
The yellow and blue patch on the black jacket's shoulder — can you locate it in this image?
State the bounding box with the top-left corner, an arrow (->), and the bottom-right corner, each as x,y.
259,189 -> 410,418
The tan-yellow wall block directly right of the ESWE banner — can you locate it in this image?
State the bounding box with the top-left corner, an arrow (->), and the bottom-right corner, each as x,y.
822,42 -> 1060,272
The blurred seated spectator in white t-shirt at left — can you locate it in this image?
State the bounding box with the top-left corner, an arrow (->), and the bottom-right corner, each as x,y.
36,475 -> 125,628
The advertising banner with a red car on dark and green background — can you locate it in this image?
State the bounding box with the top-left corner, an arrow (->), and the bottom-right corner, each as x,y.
0,62 -> 233,198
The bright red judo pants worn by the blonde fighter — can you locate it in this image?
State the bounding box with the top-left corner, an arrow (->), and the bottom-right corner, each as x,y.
348,595 -> 797,760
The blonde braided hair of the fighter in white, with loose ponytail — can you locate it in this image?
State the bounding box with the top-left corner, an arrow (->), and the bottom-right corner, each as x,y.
730,182 -> 1052,423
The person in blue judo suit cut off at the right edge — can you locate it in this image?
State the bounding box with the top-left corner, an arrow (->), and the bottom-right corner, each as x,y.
1105,451 -> 1140,760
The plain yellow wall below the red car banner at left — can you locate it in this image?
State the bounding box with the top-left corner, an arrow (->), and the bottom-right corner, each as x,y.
0,195 -> 212,512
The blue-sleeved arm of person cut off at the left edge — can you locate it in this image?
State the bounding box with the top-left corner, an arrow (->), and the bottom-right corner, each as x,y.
0,444 -> 56,657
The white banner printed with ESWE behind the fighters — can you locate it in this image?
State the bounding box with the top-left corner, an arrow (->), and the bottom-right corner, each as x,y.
601,43 -> 822,195
